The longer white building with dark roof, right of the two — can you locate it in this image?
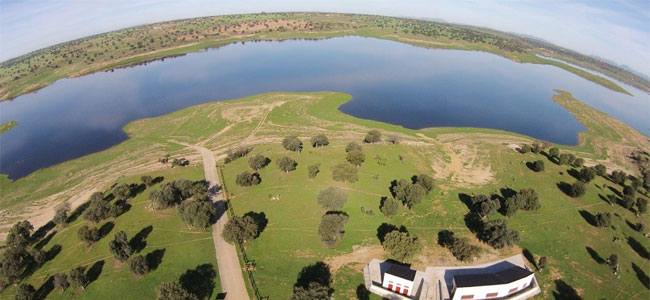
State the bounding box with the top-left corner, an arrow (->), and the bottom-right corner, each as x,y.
451,265 -> 535,300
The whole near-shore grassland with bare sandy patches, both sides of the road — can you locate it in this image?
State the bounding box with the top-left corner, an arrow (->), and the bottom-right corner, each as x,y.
0,91 -> 650,299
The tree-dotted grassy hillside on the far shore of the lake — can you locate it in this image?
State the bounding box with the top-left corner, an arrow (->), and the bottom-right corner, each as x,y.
0,13 -> 650,100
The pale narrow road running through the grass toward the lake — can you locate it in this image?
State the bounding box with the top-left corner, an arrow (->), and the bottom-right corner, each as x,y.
186,145 -> 250,300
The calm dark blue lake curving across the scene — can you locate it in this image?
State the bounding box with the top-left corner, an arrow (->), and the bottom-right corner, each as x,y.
0,37 -> 650,179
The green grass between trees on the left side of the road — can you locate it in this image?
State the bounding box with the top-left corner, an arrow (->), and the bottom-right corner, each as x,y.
0,165 -> 220,299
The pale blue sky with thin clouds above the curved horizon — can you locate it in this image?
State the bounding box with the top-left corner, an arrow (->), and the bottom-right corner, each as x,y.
0,0 -> 650,75
